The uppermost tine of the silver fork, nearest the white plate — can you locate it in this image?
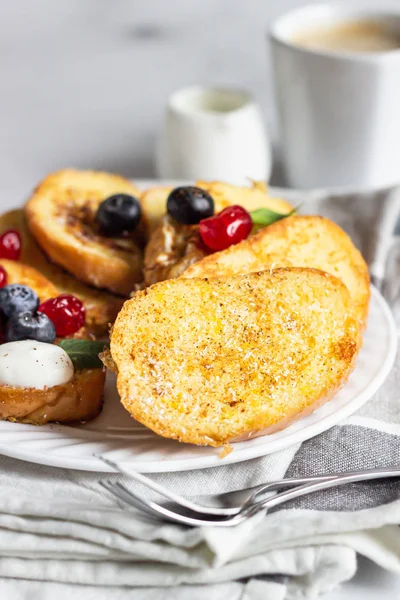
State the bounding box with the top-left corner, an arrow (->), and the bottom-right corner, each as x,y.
97,454 -> 240,516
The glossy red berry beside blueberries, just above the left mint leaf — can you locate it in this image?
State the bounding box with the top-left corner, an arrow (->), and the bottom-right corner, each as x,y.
38,294 -> 86,337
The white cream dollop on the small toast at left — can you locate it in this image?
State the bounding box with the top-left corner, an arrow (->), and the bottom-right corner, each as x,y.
0,340 -> 74,390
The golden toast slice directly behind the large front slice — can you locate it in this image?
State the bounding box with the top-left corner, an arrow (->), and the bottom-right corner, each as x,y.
182,216 -> 370,323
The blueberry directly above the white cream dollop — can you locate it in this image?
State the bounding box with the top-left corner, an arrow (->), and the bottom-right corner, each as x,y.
4,312 -> 56,344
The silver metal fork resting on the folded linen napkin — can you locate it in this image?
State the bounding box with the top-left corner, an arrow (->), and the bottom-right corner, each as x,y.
100,463 -> 400,527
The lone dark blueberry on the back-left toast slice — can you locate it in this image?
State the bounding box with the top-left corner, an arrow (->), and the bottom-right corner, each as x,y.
96,194 -> 142,236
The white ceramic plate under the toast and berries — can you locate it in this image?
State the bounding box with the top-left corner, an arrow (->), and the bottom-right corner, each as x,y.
0,289 -> 397,473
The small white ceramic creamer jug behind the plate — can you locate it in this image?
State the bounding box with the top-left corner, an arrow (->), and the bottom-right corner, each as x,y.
156,86 -> 271,185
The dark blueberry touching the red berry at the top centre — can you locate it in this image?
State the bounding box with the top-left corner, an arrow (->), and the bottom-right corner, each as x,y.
167,186 -> 214,225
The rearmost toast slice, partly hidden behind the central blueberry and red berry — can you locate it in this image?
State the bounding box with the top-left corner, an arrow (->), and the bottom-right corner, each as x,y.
141,181 -> 293,233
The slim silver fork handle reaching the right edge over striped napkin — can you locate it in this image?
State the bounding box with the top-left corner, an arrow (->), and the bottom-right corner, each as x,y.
240,467 -> 400,516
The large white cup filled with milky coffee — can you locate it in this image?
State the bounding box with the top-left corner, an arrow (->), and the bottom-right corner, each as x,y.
270,2 -> 400,189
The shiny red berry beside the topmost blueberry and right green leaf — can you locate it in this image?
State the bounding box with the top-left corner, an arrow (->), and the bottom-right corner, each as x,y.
199,205 -> 253,251
